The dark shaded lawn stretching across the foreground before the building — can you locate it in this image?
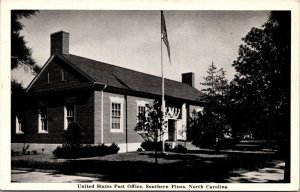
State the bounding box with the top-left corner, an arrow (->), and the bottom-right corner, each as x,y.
12,152 -> 282,183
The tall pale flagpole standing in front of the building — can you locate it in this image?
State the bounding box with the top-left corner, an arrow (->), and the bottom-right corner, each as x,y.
160,11 -> 165,152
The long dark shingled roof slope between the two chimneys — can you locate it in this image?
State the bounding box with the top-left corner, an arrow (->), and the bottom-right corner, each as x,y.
60,54 -> 203,101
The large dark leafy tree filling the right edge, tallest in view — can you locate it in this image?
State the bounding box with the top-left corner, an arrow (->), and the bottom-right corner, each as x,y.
230,11 -> 291,181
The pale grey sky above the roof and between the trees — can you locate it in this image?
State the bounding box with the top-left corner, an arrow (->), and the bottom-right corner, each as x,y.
12,10 -> 269,89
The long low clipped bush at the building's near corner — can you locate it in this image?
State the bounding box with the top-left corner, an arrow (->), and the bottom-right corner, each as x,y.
53,143 -> 120,159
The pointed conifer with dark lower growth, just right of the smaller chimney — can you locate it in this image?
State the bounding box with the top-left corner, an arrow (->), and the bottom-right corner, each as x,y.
190,63 -> 228,151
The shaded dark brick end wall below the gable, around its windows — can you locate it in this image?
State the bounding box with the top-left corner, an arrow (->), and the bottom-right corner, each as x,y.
12,93 -> 94,144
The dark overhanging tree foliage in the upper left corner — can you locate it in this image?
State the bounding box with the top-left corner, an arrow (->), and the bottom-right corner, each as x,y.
11,10 -> 40,74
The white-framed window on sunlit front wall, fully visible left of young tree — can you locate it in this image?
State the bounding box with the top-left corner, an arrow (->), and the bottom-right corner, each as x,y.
110,97 -> 124,132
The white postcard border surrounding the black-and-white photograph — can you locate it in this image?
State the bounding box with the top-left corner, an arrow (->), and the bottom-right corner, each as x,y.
0,0 -> 300,191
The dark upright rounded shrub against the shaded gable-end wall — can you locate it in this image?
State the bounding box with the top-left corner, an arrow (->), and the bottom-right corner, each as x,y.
63,123 -> 82,147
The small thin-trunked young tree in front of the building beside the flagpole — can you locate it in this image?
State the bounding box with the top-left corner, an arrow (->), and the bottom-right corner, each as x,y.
134,101 -> 165,163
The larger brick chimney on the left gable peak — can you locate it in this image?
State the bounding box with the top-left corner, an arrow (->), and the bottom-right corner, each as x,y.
50,31 -> 69,55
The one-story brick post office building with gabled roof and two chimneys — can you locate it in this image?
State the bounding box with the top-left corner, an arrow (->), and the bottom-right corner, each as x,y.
11,31 -> 202,152
